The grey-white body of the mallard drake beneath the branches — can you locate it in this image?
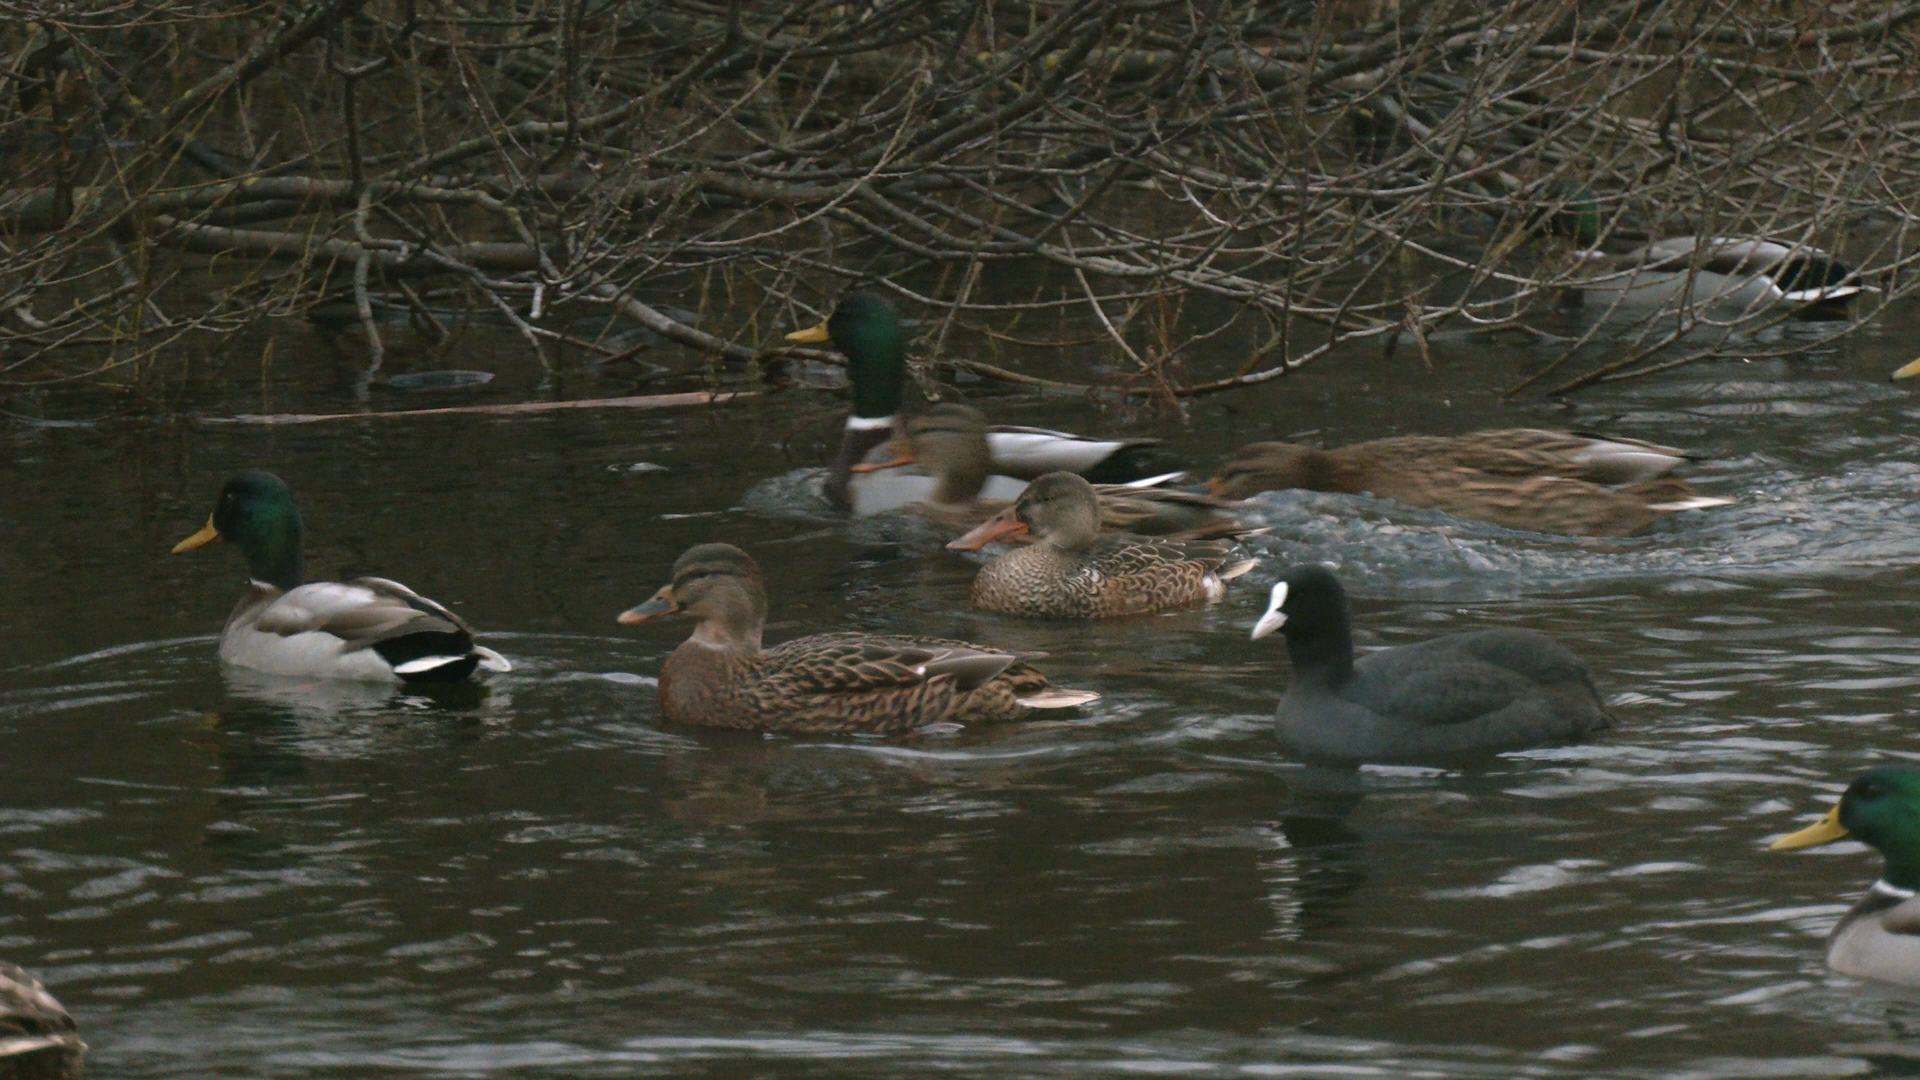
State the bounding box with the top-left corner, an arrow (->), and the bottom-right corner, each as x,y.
1563,236 -> 1866,319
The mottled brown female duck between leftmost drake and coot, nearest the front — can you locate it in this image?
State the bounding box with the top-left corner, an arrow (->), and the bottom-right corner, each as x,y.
620,544 -> 1098,734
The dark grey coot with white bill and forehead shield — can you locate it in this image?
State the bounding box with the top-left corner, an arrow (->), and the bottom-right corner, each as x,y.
1252,565 -> 1613,765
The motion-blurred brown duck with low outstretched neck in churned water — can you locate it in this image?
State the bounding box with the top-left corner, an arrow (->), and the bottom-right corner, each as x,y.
1208,429 -> 1734,536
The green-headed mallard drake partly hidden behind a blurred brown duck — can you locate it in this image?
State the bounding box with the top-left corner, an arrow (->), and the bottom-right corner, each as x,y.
787,292 -> 1158,515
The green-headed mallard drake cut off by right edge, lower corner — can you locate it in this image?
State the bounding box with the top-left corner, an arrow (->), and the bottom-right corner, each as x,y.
1770,769 -> 1920,986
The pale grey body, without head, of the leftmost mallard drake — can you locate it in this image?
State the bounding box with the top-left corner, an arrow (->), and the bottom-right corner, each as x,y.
221,578 -> 513,682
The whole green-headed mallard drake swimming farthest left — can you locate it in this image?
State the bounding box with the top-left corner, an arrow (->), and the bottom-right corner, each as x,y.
173,469 -> 513,682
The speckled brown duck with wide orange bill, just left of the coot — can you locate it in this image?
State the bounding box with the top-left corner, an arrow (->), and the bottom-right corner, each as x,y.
948,473 -> 1254,619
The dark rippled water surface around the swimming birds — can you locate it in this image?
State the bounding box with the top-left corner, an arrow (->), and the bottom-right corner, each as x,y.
11,315 -> 1920,1078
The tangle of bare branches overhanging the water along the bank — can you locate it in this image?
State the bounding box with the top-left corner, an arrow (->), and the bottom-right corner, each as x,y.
0,0 -> 1920,402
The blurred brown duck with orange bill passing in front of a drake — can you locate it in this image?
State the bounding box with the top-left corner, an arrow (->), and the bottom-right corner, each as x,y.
854,402 -> 1248,540
